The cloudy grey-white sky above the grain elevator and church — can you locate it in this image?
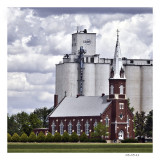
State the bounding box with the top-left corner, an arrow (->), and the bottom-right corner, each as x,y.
7,8 -> 153,114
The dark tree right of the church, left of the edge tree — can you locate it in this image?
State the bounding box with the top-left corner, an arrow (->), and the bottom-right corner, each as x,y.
134,111 -> 146,141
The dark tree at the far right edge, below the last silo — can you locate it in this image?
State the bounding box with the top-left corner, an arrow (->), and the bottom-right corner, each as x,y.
145,110 -> 153,137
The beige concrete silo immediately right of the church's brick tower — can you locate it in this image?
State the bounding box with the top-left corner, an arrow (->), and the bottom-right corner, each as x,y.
125,66 -> 141,112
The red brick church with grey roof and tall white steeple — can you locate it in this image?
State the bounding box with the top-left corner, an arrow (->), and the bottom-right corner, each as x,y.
45,30 -> 134,140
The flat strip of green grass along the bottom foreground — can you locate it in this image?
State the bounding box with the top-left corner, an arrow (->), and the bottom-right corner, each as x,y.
8,143 -> 153,153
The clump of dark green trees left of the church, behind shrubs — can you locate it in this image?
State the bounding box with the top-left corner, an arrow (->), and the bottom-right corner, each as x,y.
7,107 -> 53,136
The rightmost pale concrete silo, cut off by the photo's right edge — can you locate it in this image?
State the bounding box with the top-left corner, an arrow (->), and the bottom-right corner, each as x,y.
141,66 -> 153,114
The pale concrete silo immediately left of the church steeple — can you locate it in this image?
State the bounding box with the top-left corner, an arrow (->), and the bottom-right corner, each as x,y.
95,63 -> 110,96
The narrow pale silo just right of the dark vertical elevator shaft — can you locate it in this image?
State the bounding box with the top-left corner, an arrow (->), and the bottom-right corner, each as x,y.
83,63 -> 95,96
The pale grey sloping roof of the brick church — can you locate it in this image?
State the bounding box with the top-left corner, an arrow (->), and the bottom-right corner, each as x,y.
50,96 -> 111,117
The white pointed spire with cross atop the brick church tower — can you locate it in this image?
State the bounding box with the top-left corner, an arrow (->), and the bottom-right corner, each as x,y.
110,29 -> 125,79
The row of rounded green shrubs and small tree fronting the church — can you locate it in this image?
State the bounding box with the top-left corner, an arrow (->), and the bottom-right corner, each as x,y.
7,122 -> 108,142
